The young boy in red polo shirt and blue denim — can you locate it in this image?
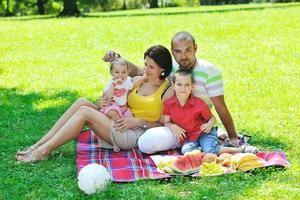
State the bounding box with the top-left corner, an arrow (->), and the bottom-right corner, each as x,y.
163,70 -> 258,154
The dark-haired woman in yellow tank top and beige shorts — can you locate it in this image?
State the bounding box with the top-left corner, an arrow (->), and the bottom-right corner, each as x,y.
16,45 -> 173,163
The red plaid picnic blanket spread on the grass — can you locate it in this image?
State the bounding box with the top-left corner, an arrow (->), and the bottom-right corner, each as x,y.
76,130 -> 290,182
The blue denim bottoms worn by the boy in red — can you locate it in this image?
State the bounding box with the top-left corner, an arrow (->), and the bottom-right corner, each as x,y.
181,127 -> 220,154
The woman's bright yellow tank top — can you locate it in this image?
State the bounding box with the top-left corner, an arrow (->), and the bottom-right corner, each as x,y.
128,80 -> 169,122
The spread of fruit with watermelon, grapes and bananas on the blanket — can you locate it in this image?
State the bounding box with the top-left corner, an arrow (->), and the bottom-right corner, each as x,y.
157,150 -> 264,175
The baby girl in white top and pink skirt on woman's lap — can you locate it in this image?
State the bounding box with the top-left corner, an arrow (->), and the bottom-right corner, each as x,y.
100,58 -> 143,121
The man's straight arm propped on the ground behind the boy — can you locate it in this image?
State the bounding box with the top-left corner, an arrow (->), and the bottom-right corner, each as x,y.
211,95 -> 239,146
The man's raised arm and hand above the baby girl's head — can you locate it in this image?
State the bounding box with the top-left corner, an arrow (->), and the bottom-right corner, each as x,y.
103,50 -> 144,77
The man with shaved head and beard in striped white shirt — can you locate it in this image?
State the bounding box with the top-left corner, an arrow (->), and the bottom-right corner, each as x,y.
103,31 -> 239,146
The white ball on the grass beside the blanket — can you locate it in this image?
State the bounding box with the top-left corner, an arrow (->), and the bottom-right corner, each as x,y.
78,163 -> 111,195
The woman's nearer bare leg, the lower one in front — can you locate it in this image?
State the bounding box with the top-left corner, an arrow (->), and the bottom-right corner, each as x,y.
17,106 -> 112,163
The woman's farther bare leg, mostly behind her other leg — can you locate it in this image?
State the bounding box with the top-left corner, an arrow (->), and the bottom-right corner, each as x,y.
16,98 -> 98,156
